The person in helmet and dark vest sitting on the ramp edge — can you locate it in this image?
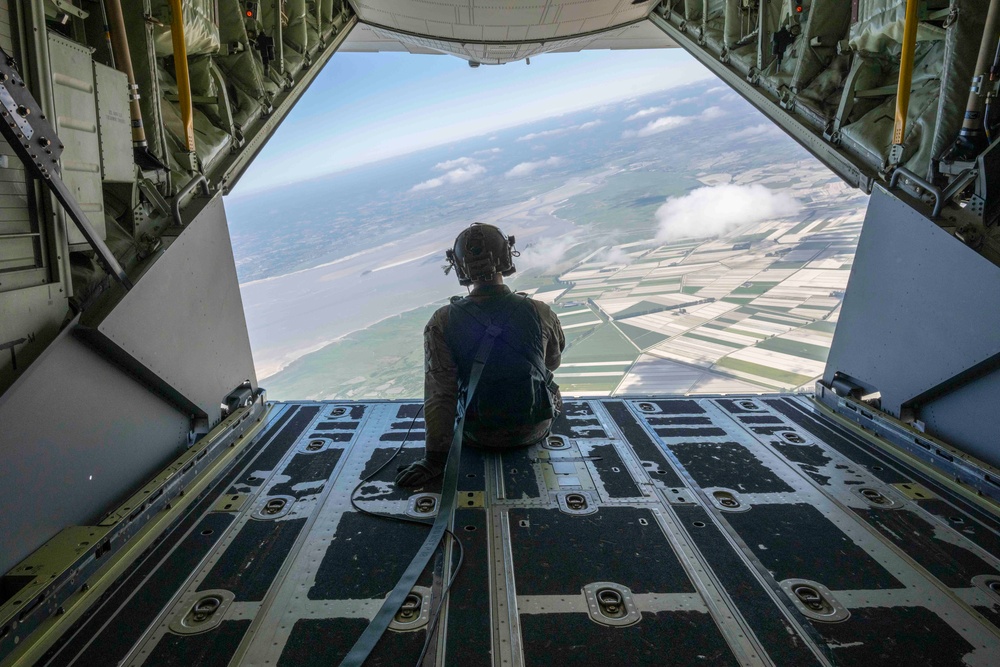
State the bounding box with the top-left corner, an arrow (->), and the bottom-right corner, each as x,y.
396,222 -> 566,487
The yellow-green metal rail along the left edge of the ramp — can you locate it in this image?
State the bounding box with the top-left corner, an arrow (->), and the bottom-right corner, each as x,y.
0,407 -> 271,667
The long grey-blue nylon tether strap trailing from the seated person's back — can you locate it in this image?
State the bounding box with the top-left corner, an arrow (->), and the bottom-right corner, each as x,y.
340,303 -> 520,667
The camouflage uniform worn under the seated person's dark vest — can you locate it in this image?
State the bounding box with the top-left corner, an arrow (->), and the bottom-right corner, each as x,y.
424,285 -> 566,454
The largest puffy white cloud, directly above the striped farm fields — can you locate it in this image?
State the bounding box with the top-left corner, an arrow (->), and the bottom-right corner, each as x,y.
656,185 -> 802,241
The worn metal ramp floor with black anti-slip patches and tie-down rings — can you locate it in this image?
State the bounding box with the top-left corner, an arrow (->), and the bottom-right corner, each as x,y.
41,396 -> 1000,667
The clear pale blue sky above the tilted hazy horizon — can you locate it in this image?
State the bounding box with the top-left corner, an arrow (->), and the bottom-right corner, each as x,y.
232,49 -> 711,197
